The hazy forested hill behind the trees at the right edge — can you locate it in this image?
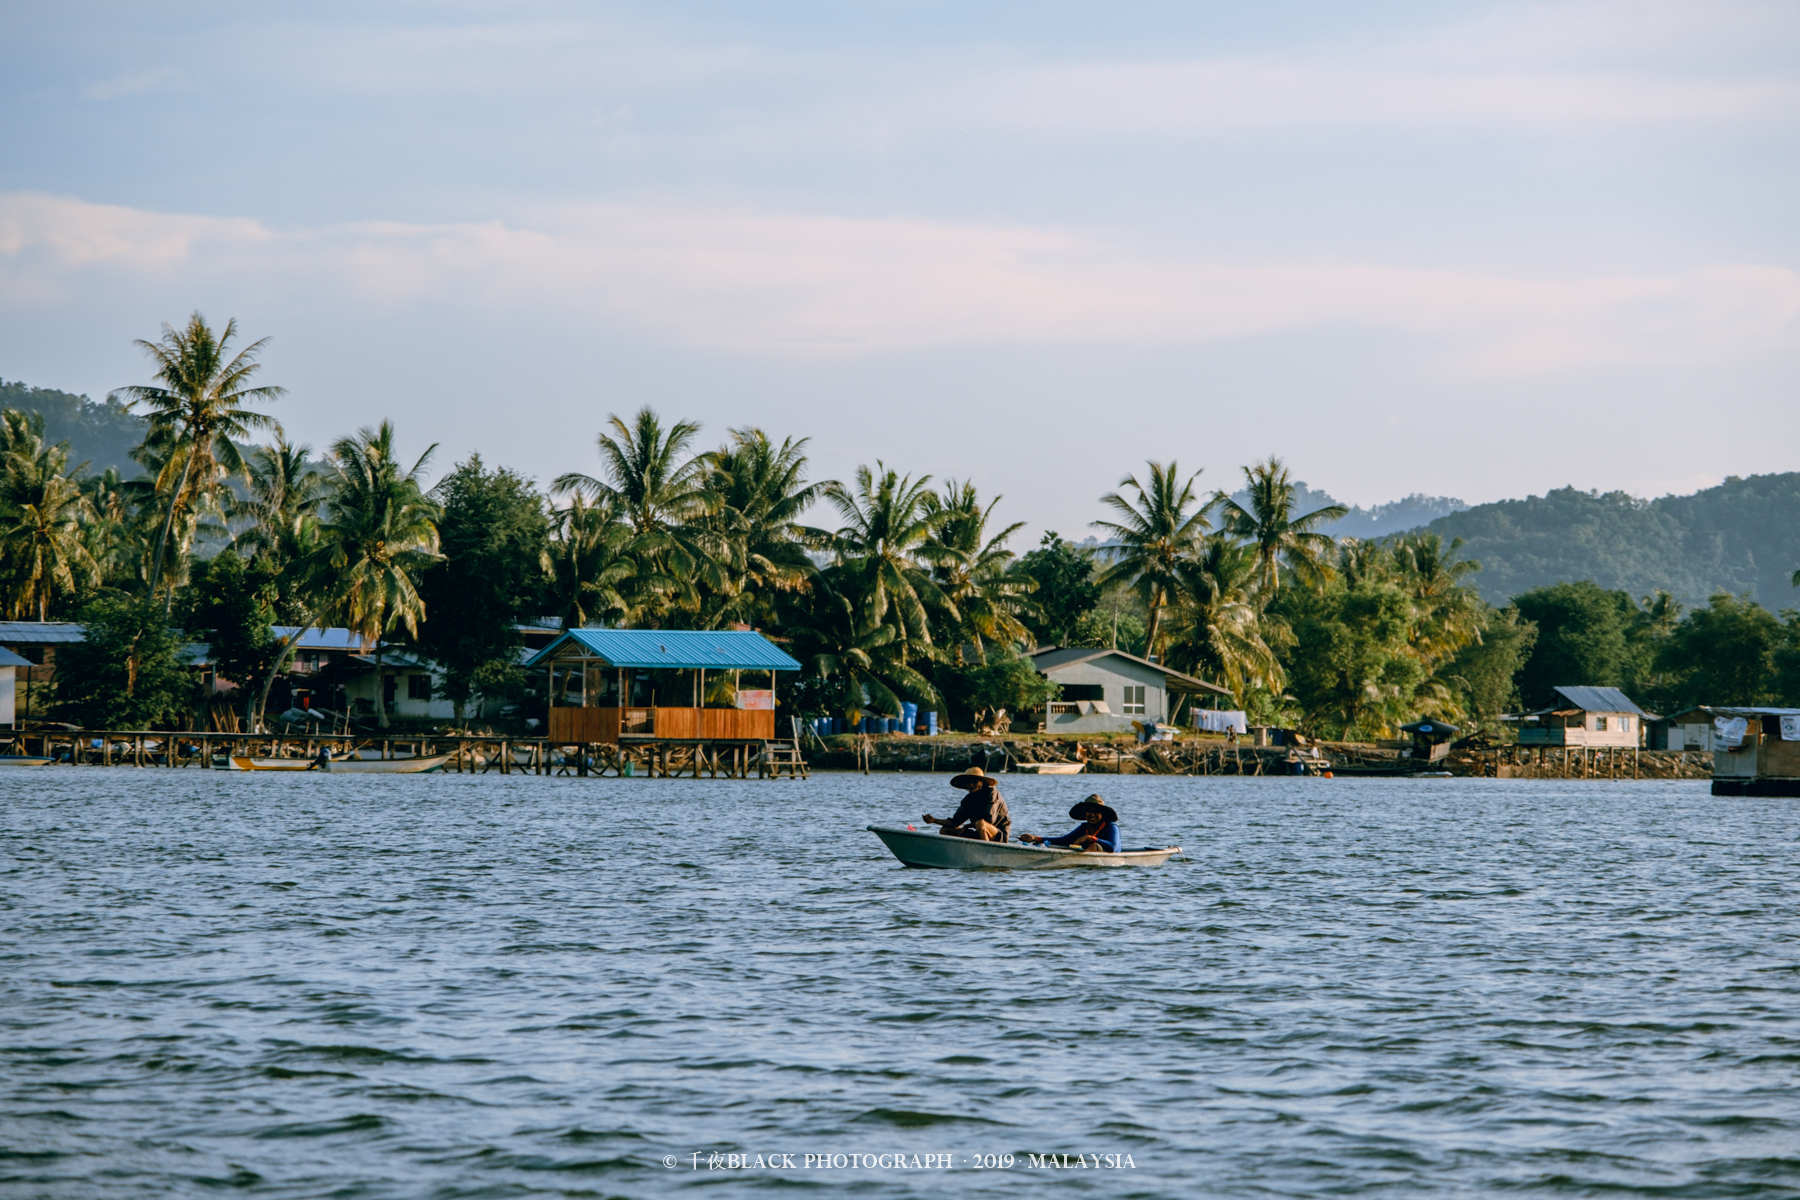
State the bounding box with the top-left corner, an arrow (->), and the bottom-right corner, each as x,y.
1426,471 -> 1800,610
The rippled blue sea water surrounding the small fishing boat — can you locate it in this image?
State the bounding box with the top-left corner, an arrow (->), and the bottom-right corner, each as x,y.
0,766 -> 1800,1198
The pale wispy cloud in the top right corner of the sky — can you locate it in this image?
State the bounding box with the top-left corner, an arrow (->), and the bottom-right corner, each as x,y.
927,0 -> 1800,137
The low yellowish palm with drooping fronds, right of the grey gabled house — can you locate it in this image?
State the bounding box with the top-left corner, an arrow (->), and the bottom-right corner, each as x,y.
1166,534 -> 1291,705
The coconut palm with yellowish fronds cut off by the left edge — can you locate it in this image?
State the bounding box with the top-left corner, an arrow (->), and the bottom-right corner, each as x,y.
0,410 -> 101,621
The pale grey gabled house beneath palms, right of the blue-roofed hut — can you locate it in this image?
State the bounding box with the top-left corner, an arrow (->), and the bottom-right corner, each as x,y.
1031,646 -> 1231,734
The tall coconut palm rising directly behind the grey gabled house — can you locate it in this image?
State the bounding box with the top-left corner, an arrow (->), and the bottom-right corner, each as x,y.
1094,462 -> 1213,655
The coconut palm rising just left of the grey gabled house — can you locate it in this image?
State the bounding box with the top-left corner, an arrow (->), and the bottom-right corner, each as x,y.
925,479 -> 1037,662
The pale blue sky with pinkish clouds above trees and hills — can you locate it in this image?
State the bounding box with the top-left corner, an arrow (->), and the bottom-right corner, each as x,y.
0,0 -> 1800,536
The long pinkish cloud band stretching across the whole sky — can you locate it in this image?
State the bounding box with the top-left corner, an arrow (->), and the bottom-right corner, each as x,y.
0,194 -> 1800,374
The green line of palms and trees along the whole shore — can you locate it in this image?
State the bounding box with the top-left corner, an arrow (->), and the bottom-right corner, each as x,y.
0,313 -> 1800,738
